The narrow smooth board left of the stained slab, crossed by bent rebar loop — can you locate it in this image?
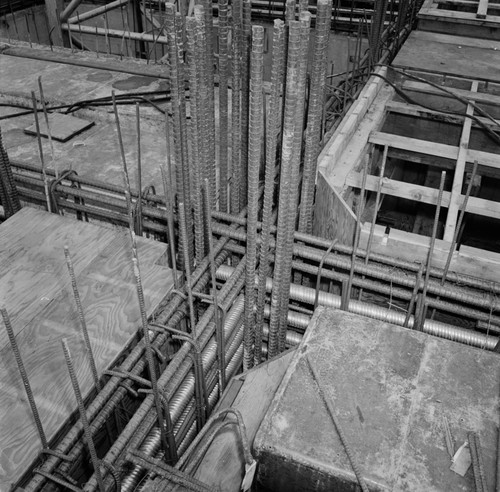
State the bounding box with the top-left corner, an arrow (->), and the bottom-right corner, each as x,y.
190,350 -> 295,492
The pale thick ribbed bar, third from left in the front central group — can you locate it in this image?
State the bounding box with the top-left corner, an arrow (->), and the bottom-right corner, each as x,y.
269,21 -> 301,357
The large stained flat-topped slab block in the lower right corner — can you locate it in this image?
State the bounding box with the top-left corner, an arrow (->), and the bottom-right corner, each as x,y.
254,308 -> 500,492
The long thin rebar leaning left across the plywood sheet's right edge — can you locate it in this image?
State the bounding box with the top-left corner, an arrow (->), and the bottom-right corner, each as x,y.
132,258 -> 169,456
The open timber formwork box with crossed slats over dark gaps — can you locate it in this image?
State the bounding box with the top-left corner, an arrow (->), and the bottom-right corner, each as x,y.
315,68 -> 500,281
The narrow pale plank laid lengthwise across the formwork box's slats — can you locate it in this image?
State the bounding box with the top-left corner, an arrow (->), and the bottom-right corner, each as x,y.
444,80 -> 479,242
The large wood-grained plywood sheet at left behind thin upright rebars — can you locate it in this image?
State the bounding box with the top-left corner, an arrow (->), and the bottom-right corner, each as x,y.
0,209 -> 173,490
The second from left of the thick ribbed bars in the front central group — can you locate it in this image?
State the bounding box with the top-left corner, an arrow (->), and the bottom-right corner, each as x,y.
254,19 -> 285,364
